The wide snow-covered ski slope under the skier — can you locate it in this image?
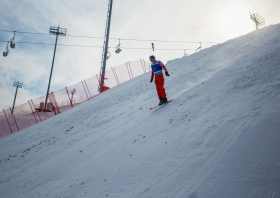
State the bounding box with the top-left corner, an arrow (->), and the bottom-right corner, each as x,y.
0,25 -> 280,198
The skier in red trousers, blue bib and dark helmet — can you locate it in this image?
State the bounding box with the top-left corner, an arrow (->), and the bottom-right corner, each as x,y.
149,55 -> 170,105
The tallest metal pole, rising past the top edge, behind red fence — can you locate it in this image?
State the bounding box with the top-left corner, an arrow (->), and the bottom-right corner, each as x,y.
99,0 -> 113,93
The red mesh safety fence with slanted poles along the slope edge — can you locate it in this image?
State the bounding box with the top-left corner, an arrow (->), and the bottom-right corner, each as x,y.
0,59 -> 150,138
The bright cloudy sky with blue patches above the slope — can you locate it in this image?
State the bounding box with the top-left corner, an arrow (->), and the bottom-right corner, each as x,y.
0,0 -> 280,109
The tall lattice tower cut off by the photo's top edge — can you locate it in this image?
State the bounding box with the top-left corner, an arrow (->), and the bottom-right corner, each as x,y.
99,0 -> 113,93
